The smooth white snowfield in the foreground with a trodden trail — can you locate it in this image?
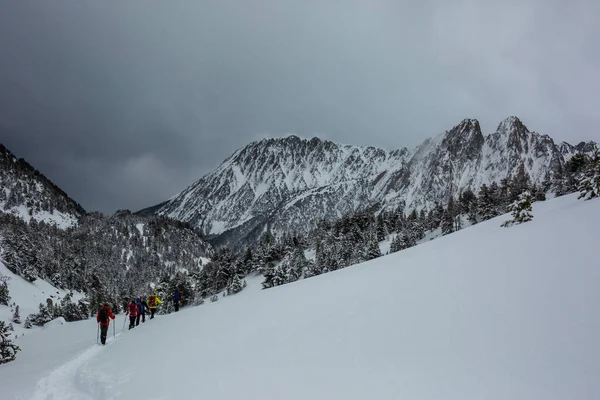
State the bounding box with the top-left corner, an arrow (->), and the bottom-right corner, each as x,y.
0,195 -> 600,400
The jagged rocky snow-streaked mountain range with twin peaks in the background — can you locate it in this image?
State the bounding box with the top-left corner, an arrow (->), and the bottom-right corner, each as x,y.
141,117 -> 589,245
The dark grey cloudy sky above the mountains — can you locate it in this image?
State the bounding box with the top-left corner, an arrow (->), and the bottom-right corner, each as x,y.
0,0 -> 600,213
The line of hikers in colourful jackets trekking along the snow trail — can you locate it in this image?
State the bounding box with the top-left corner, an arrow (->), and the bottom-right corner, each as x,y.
96,290 -> 181,344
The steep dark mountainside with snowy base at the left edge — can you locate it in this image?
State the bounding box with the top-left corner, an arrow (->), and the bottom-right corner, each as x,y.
0,144 -> 85,228
